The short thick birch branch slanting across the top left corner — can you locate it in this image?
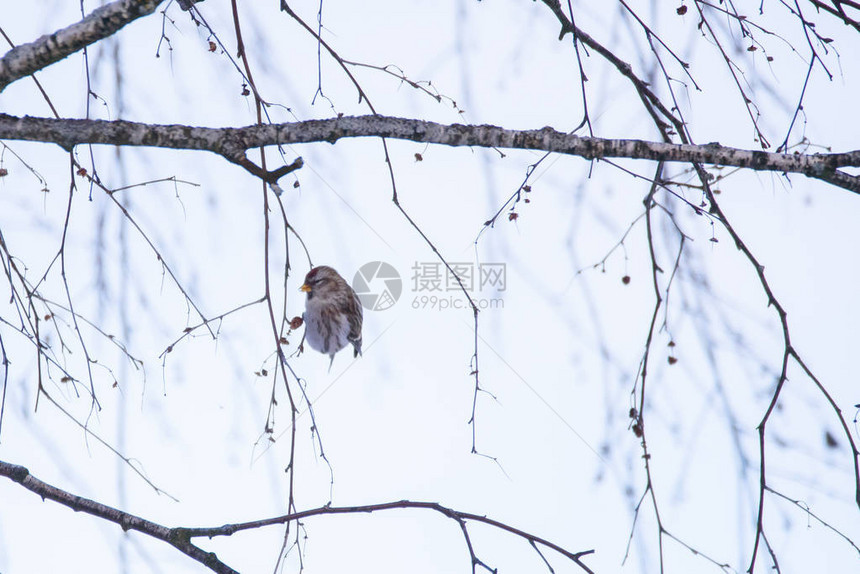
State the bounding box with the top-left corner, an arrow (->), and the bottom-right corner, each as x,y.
0,0 -> 162,92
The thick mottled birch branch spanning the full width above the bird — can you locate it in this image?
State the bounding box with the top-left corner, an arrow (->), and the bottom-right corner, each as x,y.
0,114 -> 860,193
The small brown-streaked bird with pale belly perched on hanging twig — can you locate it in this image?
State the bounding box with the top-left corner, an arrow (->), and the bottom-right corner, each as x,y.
299,265 -> 363,370
